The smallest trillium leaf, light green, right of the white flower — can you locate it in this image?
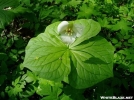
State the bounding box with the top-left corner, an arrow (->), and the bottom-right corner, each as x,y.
70,19 -> 101,47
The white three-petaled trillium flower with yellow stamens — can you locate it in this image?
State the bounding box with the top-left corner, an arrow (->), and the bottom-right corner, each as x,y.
57,21 -> 82,44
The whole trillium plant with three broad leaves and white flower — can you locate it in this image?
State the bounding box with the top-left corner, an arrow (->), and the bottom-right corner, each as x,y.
23,19 -> 114,89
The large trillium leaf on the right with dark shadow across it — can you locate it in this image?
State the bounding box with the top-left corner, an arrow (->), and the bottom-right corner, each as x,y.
69,36 -> 114,88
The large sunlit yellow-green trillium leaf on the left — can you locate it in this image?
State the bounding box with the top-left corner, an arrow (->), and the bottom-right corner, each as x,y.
24,30 -> 70,81
